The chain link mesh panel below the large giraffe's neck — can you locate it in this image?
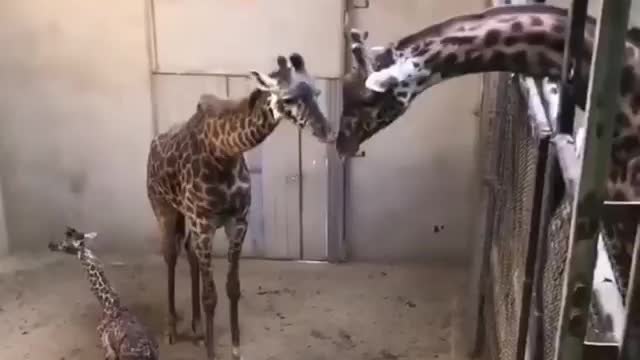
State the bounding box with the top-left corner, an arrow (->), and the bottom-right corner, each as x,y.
480,73 -> 538,360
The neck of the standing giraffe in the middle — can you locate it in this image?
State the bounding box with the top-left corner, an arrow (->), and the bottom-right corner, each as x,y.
204,89 -> 279,156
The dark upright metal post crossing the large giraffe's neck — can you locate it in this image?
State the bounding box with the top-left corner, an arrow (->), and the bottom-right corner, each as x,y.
558,0 -> 589,134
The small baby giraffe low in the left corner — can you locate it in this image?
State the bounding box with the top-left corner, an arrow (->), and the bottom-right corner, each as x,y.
49,227 -> 159,360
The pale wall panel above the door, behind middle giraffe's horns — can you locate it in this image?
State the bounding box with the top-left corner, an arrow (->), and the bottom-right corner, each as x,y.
154,0 -> 344,78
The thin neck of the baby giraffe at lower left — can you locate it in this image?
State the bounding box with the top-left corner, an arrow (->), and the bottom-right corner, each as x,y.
78,247 -> 121,315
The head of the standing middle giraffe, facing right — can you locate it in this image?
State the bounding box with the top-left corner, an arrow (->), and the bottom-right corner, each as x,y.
250,53 -> 337,142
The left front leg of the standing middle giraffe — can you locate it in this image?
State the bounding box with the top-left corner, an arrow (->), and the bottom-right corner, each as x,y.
192,228 -> 218,360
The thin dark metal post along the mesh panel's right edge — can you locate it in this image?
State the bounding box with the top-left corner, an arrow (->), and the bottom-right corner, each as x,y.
516,139 -> 549,360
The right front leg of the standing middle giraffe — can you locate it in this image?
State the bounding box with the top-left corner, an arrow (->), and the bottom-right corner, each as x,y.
225,218 -> 247,360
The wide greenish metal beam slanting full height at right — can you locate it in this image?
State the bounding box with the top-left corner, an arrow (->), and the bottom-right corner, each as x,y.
554,0 -> 630,360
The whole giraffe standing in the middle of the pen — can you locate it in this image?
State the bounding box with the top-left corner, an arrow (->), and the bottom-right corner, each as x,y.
147,53 -> 336,360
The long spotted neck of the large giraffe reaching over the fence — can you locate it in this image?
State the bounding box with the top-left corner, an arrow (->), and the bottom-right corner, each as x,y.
368,5 -> 640,107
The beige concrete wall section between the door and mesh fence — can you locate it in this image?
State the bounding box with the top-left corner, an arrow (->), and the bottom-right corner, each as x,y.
345,0 -> 484,262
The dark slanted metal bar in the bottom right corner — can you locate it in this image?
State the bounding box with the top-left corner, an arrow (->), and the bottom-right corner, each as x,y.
619,224 -> 640,360
